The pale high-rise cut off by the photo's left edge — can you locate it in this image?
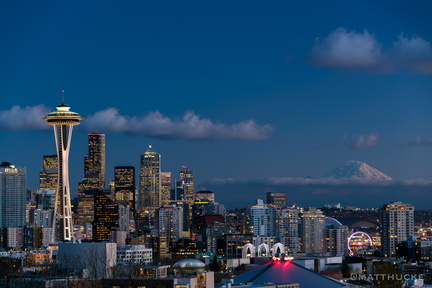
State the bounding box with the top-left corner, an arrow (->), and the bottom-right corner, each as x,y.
0,162 -> 26,228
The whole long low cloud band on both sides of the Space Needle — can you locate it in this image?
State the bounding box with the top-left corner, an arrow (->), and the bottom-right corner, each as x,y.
0,105 -> 274,141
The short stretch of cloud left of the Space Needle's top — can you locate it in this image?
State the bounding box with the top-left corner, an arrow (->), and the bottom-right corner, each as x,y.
0,105 -> 50,130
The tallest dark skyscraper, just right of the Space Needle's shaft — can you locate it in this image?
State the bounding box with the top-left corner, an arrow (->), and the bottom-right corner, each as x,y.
78,132 -> 106,191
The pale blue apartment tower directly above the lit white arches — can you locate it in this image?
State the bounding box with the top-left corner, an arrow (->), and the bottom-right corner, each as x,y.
249,199 -> 276,237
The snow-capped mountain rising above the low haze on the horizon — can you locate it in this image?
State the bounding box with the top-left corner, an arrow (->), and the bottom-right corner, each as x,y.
323,161 -> 393,180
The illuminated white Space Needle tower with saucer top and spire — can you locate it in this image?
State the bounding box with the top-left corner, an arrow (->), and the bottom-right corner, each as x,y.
42,90 -> 84,242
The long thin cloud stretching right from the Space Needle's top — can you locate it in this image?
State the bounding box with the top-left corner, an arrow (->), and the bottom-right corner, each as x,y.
83,108 -> 273,141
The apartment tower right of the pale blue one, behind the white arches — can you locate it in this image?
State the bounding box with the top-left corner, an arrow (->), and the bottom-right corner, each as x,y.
275,207 -> 300,253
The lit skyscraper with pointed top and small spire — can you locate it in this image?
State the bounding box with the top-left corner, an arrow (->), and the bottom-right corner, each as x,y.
139,145 -> 161,216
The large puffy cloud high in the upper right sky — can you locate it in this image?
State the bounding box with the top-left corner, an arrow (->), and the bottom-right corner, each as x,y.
310,28 -> 432,74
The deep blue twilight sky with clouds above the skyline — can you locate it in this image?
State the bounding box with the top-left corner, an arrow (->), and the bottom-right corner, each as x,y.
0,0 -> 432,205
